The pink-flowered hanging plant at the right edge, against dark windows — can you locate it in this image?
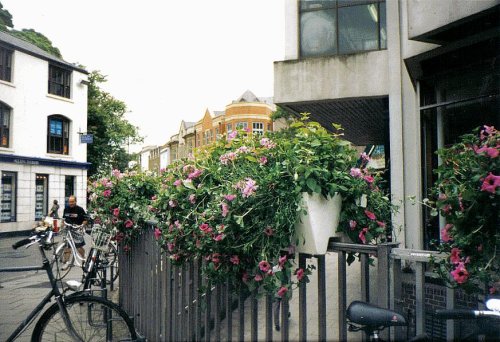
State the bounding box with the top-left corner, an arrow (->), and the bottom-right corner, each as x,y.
430,126 -> 500,293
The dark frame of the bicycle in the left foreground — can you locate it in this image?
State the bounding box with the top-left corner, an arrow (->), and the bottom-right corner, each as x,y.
0,236 -> 81,342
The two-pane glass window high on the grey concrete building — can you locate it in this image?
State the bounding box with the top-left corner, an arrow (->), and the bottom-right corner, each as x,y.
300,0 -> 387,57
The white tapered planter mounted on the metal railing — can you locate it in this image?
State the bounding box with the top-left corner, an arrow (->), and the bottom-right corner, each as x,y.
295,193 -> 342,255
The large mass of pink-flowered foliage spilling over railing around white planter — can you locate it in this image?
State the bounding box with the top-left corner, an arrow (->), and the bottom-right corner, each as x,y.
91,116 -> 392,297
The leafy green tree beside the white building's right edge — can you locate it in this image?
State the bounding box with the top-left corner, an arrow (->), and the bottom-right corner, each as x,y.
87,71 -> 143,178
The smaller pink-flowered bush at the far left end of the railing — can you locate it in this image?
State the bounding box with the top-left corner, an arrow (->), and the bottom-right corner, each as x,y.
89,170 -> 158,251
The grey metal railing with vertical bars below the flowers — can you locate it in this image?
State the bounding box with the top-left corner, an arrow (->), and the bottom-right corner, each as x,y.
119,229 -> 478,341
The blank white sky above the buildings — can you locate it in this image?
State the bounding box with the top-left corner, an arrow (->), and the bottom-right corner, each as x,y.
0,0 -> 286,150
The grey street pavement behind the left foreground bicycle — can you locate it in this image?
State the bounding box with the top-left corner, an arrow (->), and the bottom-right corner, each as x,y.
0,231 -> 117,342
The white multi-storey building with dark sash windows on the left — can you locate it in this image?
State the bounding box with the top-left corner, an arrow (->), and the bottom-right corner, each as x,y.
0,31 -> 89,233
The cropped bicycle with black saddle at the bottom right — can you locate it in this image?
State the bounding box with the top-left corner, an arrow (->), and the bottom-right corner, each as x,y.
346,299 -> 500,342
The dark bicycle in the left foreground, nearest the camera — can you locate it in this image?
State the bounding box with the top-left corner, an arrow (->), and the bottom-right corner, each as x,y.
0,227 -> 137,342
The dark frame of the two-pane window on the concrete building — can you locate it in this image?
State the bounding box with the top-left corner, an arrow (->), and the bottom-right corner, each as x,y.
298,0 -> 387,59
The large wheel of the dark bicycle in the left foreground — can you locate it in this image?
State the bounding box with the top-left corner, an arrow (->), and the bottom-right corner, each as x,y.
31,295 -> 137,342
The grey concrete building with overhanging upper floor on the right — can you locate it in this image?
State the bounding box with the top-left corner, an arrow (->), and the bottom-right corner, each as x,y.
274,0 -> 500,249
